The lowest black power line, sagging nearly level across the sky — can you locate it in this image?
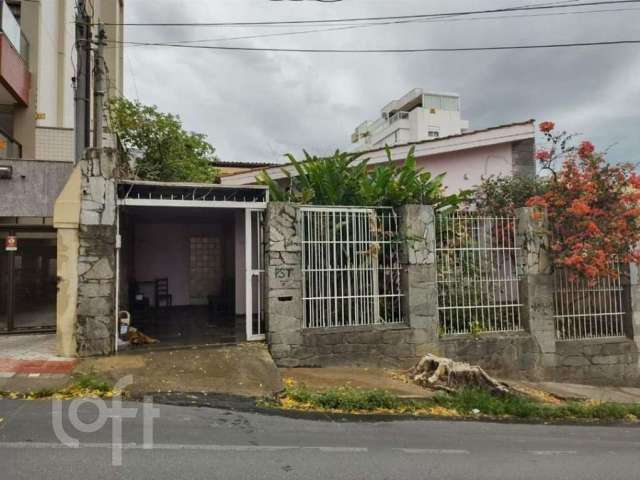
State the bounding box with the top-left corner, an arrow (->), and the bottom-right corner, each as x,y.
116,40 -> 640,53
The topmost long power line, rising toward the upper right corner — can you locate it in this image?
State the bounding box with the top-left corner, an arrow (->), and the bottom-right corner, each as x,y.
105,0 -> 640,27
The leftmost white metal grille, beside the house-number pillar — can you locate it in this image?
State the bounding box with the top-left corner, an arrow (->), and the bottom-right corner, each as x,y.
300,207 -> 403,328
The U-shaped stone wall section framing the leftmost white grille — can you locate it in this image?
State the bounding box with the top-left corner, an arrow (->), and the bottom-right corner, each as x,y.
265,202 -> 436,367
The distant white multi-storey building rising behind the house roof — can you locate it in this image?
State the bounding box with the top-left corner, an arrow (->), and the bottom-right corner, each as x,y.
351,88 -> 469,150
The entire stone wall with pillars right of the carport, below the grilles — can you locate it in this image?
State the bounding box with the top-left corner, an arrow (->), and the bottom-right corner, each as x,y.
265,203 -> 640,385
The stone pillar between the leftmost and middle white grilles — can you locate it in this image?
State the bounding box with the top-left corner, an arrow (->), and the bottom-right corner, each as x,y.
399,205 -> 438,344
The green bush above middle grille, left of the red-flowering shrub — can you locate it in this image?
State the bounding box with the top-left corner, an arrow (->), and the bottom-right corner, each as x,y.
475,175 -> 549,217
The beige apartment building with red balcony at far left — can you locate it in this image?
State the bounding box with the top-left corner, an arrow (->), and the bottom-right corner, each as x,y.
0,0 -> 123,334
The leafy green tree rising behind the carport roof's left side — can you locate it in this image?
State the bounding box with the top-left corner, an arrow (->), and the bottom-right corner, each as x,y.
109,97 -> 218,182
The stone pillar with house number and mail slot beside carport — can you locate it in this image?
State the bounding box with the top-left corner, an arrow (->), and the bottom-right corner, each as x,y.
265,202 -> 302,366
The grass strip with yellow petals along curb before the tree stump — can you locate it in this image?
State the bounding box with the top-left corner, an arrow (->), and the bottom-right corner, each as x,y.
272,381 -> 640,422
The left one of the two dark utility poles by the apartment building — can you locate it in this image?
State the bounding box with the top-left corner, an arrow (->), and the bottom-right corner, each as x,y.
74,0 -> 91,163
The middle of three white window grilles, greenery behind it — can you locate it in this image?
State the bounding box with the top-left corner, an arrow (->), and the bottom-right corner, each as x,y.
436,212 -> 522,335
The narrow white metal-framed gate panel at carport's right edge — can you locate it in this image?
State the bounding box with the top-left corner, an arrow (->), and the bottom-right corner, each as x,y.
245,210 -> 265,340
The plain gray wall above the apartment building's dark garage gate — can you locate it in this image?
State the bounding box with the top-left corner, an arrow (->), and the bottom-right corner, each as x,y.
0,160 -> 73,217
